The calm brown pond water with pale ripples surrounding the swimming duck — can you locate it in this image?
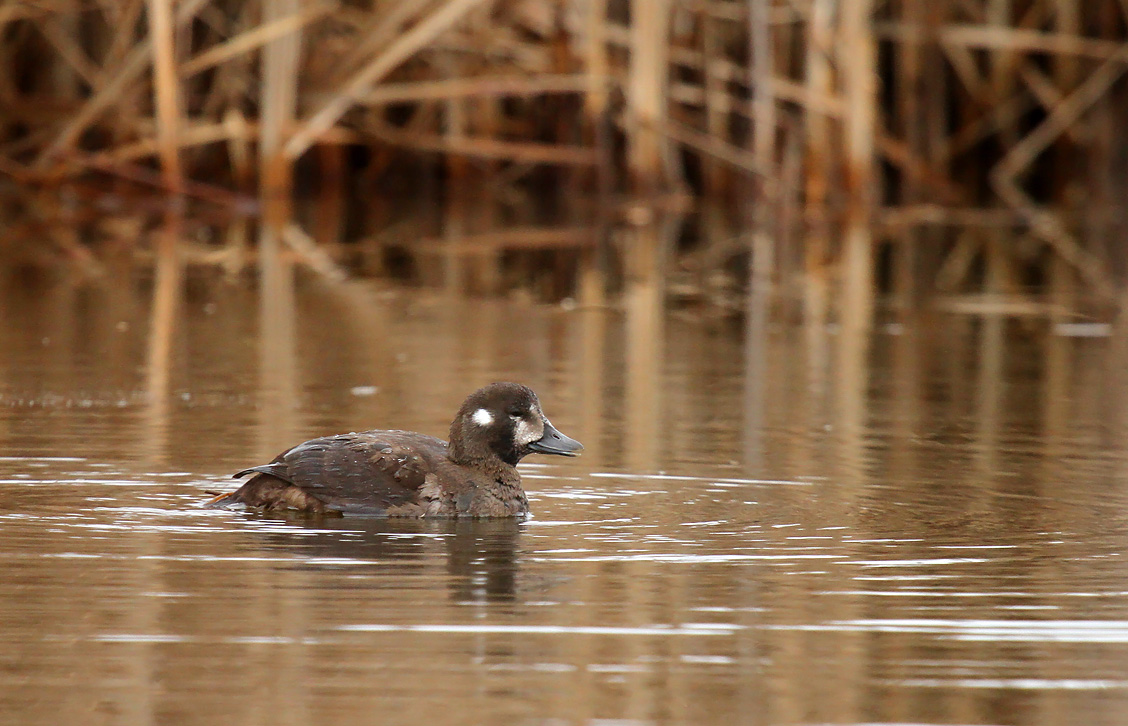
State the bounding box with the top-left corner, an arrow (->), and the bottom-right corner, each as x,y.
0,268 -> 1128,726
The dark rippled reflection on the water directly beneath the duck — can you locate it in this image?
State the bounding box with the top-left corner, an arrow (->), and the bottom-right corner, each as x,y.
249,516 -> 521,603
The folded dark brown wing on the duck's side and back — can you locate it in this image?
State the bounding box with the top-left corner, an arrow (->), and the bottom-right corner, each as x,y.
235,431 -> 447,515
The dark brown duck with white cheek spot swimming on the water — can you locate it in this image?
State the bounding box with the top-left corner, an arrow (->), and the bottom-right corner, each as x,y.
206,381 -> 583,519
